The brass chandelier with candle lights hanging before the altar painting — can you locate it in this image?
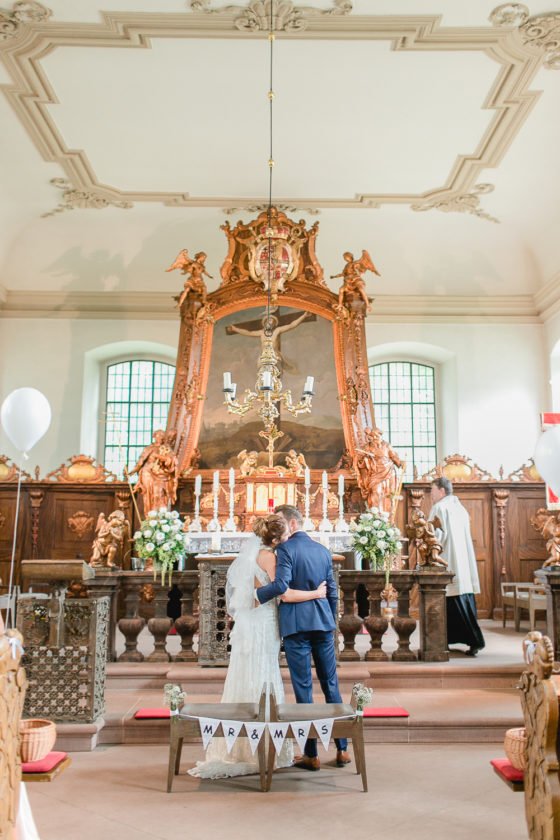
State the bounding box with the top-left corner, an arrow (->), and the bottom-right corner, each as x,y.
223,334 -> 314,467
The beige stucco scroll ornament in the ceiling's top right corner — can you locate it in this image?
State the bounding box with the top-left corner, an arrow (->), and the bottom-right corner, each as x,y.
489,3 -> 560,70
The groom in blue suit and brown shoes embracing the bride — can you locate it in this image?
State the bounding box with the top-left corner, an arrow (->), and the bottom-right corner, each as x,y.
256,505 -> 350,770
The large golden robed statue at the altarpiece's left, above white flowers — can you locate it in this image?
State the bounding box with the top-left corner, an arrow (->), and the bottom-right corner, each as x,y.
128,429 -> 179,515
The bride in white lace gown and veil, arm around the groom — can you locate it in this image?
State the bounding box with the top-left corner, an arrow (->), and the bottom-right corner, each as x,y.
189,514 -> 326,779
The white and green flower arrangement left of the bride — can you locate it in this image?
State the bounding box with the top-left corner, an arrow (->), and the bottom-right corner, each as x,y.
134,507 -> 190,586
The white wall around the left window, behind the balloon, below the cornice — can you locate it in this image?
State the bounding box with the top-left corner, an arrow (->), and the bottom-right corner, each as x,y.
0,318 -> 179,475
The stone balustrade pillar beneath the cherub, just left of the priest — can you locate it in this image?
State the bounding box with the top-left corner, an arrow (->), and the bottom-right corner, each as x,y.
414,566 -> 453,662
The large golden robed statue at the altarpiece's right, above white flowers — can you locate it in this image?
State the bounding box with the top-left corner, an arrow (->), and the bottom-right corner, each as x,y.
354,428 -> 406,514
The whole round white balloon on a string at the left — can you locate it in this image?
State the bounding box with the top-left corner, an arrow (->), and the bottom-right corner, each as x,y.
0,388 -> 52,453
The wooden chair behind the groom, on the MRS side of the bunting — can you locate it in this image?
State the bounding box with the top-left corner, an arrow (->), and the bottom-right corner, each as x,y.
266,691 -> 368,793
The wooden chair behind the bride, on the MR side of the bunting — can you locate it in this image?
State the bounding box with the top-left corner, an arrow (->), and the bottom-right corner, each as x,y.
167,690 -> 267,793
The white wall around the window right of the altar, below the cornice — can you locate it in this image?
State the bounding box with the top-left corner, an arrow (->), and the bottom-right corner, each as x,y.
367,323 -> 550,477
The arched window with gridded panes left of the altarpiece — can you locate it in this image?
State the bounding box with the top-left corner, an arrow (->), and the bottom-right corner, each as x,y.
103,359 -> 175,476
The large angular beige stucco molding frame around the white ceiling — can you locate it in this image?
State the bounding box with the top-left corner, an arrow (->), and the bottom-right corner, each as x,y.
0,4 -> 555,220
